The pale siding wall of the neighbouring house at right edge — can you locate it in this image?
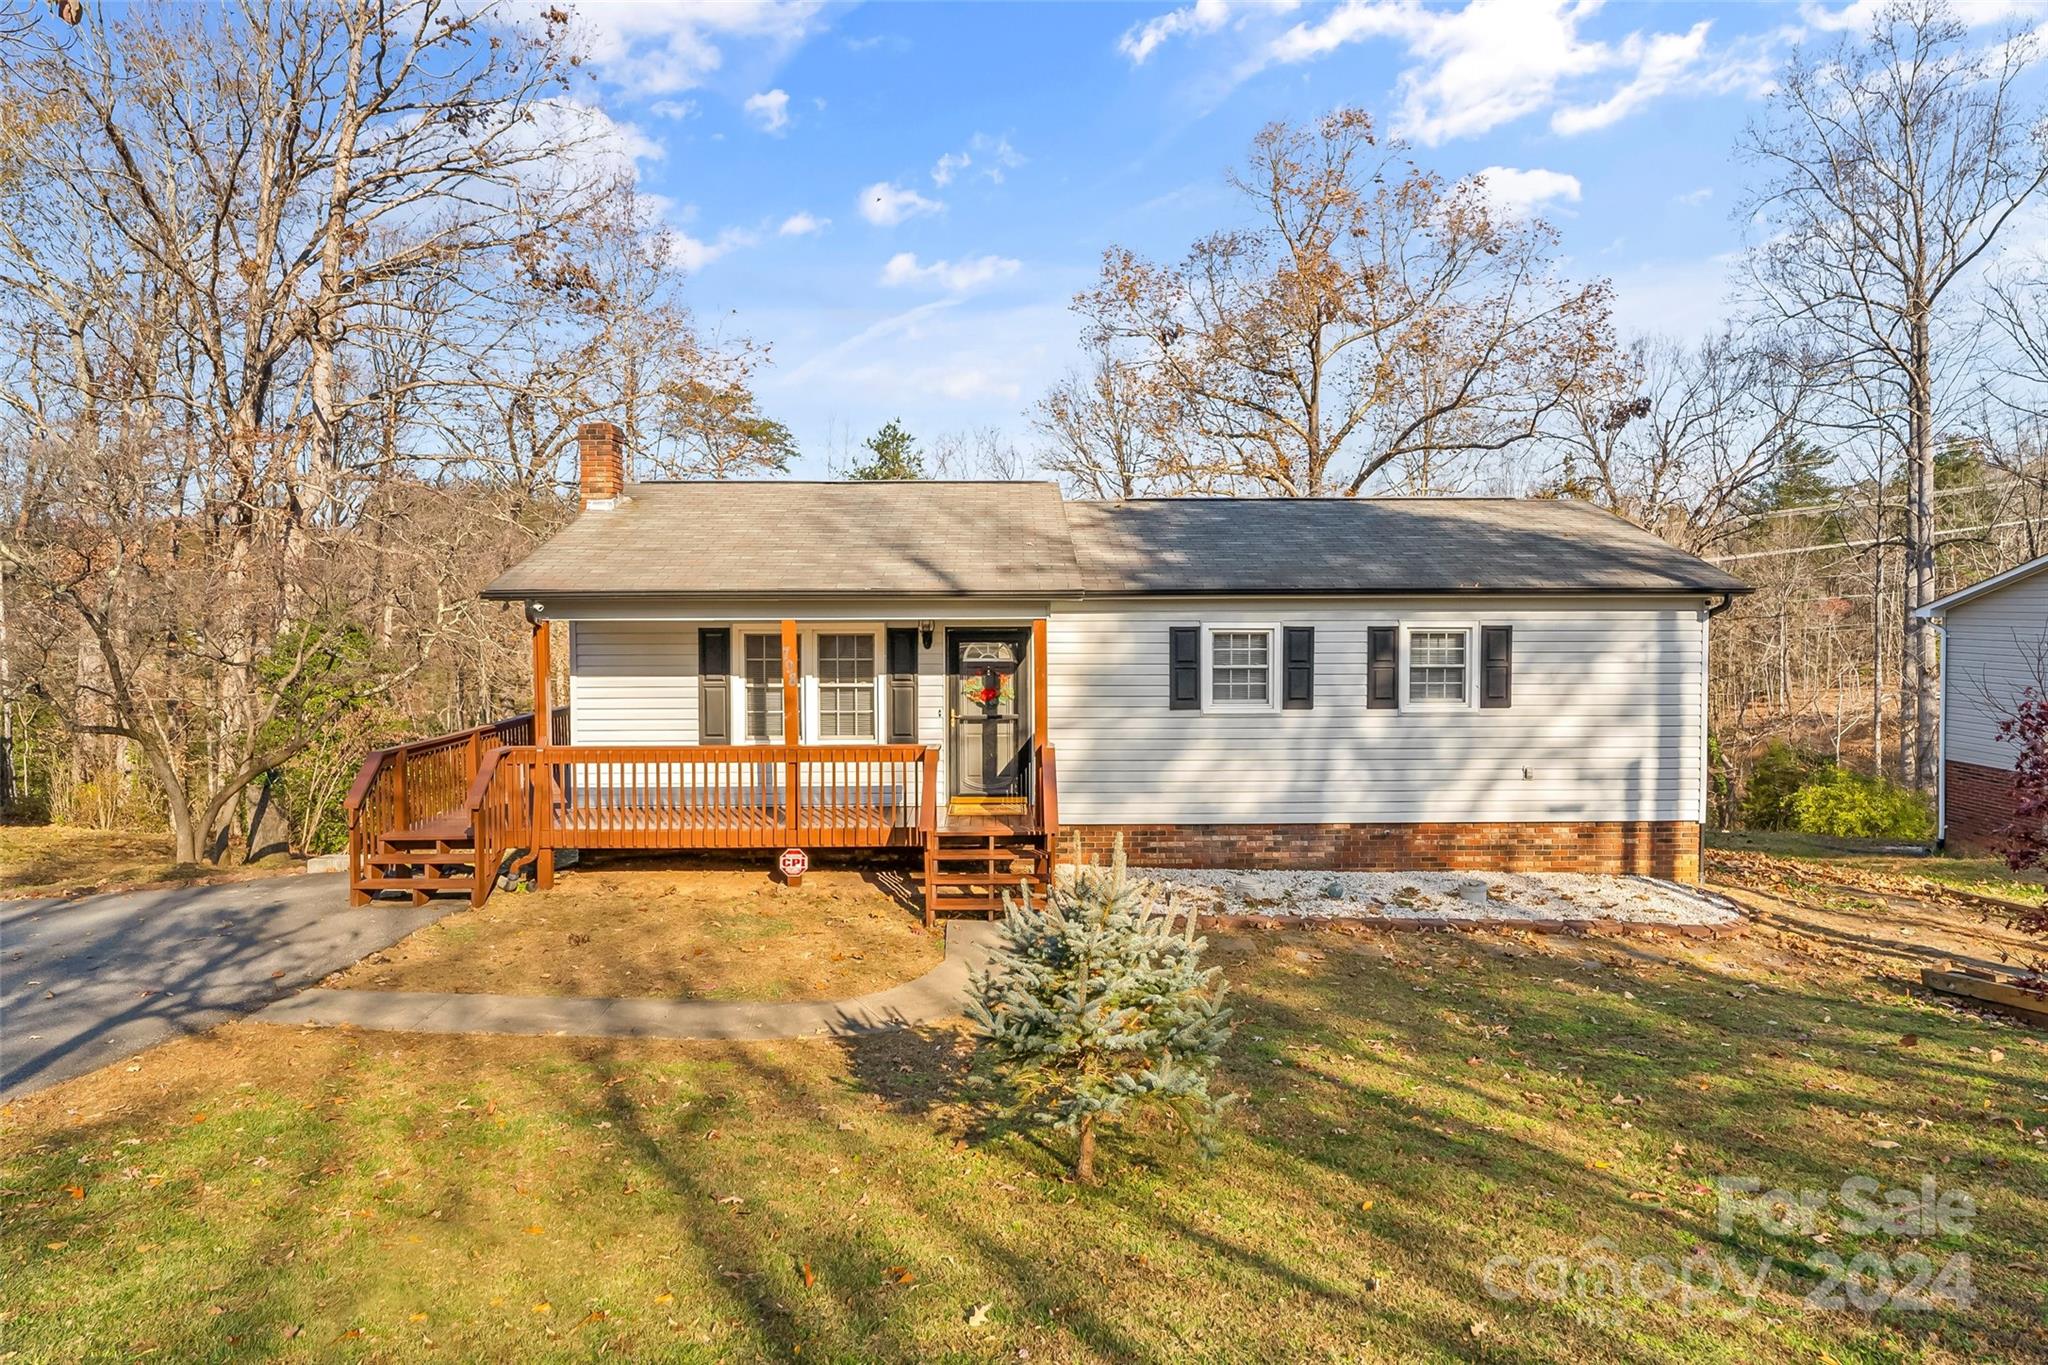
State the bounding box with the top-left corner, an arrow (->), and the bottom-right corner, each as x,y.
1942,573 -> 2048,772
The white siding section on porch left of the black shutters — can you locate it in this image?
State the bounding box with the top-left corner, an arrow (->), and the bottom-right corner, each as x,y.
569,620 -> 696,745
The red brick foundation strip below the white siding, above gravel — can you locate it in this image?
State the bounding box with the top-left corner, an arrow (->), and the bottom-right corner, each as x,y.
1059,821 -> 1700,882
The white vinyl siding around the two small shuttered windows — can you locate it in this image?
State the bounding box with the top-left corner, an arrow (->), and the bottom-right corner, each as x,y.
1049,598 -> 1706,825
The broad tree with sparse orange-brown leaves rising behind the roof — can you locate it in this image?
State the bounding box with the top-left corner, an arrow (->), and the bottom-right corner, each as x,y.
1075,108 -> 1612,497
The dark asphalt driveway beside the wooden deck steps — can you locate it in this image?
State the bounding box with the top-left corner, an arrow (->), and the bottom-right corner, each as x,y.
0,874 -> 450,1099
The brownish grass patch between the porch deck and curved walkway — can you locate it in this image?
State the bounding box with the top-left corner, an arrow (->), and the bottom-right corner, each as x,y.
324,862 -> 944,1001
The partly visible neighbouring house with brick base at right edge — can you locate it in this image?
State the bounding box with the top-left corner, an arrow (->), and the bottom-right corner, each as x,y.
1915,555 -> 2048,849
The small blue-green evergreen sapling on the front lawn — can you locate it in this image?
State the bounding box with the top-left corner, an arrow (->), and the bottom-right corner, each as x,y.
967,841 -> 1231,1183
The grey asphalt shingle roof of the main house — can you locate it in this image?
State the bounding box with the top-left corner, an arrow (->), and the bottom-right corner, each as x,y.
483,481 -> 1747,598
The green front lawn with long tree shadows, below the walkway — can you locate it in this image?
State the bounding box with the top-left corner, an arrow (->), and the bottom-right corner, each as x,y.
0,879 -> 2048,1361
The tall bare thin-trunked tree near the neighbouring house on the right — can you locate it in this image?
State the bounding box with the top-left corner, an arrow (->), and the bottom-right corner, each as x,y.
1743,0 -> 2048,786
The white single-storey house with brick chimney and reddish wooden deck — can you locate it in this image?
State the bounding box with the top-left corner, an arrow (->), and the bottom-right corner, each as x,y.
350,424 -> 1745,913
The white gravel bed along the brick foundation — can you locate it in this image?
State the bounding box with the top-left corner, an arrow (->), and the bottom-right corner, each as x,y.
1130,868 -> 1741,925
